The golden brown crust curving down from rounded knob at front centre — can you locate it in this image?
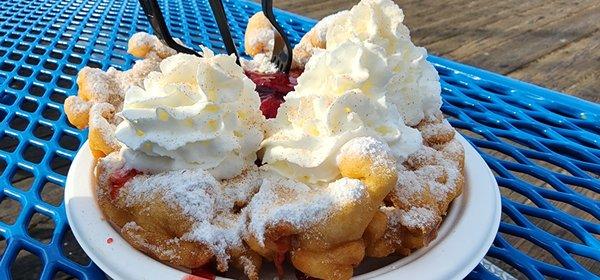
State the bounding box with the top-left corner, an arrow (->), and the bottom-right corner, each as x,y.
245,138 -> 397,279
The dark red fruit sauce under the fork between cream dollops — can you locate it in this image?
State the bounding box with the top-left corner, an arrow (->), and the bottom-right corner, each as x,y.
246,70 -> 302,118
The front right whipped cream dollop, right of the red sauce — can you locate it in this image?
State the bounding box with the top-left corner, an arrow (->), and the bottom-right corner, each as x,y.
262,39 -> 422,184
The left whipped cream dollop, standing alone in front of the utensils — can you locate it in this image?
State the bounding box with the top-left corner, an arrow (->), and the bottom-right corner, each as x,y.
116,48 -> 265,179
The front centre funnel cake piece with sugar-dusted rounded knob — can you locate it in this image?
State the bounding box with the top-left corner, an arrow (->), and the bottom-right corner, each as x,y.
245,137 -> 397,279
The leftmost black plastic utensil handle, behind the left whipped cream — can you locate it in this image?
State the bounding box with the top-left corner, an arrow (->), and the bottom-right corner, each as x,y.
139,0 -> 202,57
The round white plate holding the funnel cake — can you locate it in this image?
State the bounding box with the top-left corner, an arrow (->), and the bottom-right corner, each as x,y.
65,136 -> 501,280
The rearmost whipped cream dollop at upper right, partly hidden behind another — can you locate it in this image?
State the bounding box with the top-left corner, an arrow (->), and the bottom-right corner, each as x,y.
326,0 -> 442,126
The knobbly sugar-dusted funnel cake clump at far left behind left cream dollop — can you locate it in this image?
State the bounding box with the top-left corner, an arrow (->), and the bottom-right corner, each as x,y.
64,32 -> 175,158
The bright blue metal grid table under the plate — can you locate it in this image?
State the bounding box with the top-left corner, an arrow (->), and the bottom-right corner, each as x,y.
0,0 -> 600,279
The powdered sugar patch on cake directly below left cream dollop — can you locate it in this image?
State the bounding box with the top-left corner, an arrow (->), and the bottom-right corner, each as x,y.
120,168 -> 260,268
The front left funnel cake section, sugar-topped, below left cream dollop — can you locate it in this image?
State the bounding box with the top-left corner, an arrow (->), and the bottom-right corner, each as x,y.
96,153 -> 262,279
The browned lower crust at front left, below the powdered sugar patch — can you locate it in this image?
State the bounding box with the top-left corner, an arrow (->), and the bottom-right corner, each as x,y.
96,156 -> 262,279
